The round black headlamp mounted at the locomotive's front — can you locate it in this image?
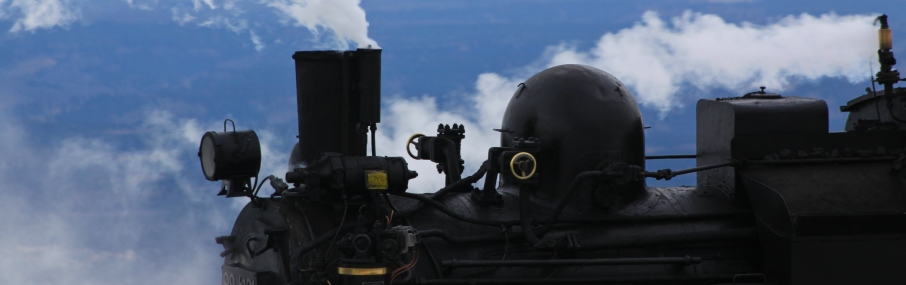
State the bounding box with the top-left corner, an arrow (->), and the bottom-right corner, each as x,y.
198,119 -> 261,197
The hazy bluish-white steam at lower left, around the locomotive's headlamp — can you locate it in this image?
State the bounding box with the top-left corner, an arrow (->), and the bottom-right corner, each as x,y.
0,109 -> 286,284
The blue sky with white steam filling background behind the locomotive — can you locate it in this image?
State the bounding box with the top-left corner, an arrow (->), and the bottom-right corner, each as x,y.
0,0 -> 906,284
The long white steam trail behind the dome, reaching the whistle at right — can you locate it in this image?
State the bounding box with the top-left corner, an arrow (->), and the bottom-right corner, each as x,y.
378,12 -> 877,192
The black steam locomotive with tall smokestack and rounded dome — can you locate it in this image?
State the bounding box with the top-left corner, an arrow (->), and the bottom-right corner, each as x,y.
198,15 -> 906,285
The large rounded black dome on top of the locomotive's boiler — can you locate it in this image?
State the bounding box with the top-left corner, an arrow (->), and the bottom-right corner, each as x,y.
501,64 -> 645,207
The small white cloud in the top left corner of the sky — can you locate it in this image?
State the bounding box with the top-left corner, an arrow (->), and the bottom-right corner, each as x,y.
0,0 -> 80,33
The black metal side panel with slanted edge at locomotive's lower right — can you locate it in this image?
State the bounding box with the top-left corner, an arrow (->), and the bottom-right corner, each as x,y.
739,160 -> 906,284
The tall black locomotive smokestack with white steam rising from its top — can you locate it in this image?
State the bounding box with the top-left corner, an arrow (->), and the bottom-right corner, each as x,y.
293,49 -> 381,165
